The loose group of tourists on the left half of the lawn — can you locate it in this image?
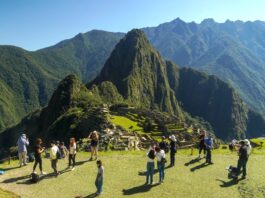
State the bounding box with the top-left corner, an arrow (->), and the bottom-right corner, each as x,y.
17,131 -> 104,195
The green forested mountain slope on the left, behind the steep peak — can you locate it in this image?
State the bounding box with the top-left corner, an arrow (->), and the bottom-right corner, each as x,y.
0,30 -> 122,132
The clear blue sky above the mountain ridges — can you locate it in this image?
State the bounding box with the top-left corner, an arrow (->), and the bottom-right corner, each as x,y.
0,0 -> 265,50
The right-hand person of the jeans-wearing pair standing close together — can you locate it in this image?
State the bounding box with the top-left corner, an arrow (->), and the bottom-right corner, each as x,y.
155,147 -> 166,184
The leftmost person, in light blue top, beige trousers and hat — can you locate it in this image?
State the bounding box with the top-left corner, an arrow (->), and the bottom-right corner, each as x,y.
17,134 -> 29,167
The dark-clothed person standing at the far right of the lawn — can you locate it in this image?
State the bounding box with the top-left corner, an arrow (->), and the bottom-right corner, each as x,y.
237,140 -> 251,179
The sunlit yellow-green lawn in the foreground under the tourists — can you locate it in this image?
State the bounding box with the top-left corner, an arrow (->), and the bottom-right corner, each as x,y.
0,150 -> 265,198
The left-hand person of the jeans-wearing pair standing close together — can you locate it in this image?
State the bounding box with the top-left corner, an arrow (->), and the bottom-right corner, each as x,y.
145,143 -> 156,185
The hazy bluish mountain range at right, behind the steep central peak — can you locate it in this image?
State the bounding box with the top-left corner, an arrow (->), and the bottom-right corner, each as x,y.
143,18 -> 265,115
